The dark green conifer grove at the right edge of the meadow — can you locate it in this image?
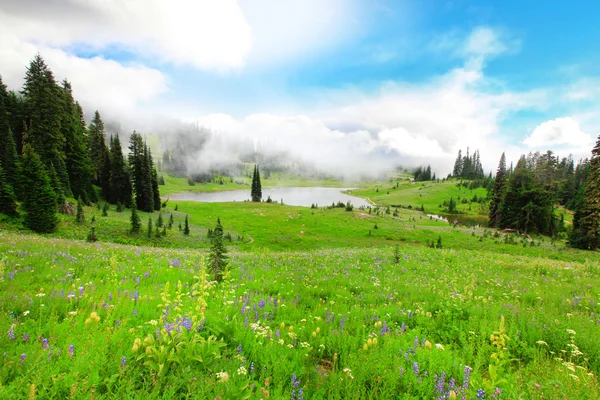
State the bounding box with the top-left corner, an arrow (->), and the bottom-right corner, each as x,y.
489,144 -> 600,249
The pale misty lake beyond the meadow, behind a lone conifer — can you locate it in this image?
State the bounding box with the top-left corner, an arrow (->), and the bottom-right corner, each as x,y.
168,187 -> 370,207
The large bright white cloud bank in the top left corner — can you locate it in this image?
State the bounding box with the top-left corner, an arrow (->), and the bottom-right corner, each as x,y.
0,0 -> 252,70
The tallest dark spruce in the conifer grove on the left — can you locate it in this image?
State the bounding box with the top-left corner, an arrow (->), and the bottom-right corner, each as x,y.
23,54 -> 72,197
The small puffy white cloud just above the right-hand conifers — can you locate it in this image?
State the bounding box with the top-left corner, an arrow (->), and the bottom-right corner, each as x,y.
523,117 -> 593,148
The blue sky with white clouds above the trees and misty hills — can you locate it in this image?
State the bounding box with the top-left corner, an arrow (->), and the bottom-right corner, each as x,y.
0,0 -> 600,175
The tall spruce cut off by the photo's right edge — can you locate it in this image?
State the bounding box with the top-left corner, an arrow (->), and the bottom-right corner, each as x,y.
569,136 -> 600,250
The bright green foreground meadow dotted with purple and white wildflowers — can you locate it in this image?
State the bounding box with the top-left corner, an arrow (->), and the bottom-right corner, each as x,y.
0,233 -> 600,399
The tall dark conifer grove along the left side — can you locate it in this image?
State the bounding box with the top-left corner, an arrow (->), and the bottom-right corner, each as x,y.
0,54 -> 161,232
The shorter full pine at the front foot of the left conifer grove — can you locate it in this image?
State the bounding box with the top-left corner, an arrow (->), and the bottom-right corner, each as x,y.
23,144 -> 58,233
